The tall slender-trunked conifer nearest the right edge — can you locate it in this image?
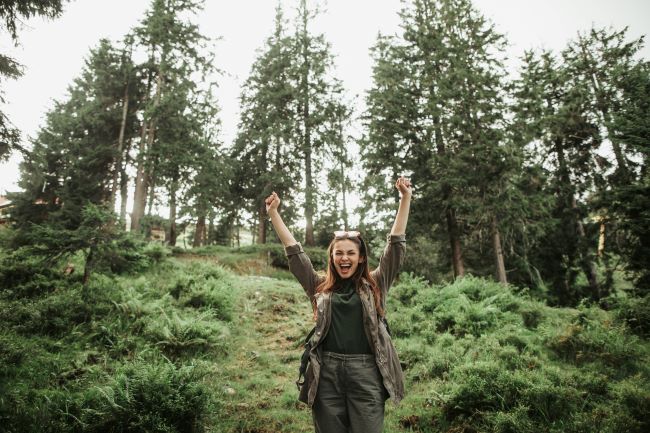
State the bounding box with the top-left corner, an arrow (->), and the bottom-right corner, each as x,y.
562,28 -> 643,293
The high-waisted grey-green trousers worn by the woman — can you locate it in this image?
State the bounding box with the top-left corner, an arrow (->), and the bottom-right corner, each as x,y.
312,352 -> 388,433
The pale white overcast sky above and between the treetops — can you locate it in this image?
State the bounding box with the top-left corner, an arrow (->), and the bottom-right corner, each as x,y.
0,0 -> 650,194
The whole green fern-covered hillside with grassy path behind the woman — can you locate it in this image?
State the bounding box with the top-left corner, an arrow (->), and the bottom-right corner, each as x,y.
0,246 -> 650,433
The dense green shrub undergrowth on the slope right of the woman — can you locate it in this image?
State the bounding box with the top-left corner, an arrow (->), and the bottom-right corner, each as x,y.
388,276 -> 650,432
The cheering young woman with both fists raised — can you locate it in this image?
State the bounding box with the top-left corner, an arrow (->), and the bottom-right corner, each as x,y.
266,177 -> 412,433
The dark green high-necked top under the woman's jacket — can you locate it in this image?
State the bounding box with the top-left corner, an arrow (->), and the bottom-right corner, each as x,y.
323,278 -> 372,355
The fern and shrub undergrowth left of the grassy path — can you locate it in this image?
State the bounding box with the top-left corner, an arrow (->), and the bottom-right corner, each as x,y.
0,245 -> 236,432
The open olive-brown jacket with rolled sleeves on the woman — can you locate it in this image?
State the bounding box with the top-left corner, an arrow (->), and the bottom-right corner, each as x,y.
285,235 -> 406,407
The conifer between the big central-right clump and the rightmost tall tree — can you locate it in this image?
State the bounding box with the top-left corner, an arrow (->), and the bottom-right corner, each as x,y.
517,52 -> 601,305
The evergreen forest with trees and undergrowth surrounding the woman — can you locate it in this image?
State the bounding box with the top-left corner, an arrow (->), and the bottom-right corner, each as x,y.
0,0 -> 650,433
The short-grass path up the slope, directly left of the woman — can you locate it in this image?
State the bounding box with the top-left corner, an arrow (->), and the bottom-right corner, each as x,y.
209,276 -> 313,433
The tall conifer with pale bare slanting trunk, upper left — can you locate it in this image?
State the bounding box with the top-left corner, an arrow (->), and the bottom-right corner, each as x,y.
126,0 -> 211,230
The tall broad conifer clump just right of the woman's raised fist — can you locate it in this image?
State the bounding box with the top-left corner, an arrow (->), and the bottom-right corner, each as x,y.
362,0 -> 516,281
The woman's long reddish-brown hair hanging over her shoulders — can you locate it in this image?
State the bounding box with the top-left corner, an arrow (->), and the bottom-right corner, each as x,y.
312,235 -> 384,319
